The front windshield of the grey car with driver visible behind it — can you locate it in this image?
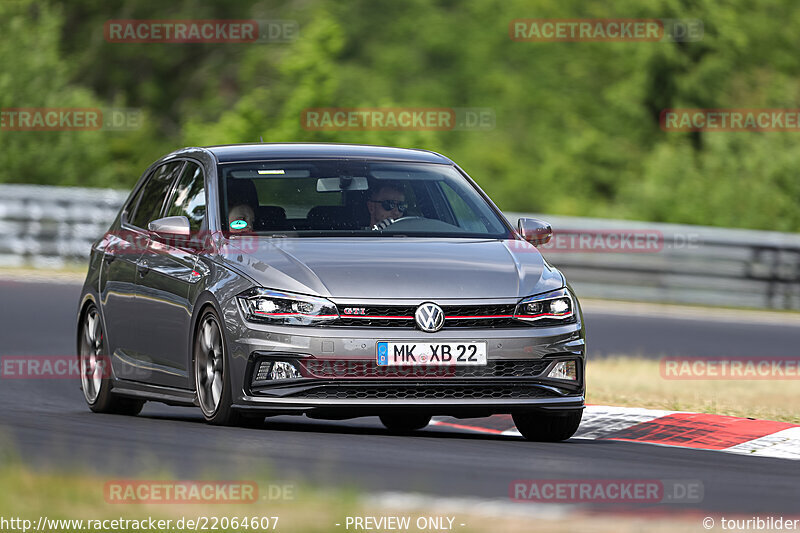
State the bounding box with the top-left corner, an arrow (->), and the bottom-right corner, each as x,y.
220,160 -> 509,239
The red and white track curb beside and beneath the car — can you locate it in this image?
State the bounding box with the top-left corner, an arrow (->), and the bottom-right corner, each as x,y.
431,405 -> 800,459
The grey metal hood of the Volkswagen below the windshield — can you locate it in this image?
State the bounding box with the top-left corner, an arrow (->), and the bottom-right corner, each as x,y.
222,237 -> 564,300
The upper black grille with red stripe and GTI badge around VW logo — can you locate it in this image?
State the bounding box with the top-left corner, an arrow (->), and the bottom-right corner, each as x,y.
332,304 -> 544,329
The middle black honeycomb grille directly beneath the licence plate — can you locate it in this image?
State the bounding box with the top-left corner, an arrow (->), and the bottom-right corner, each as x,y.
299,359 -> 551,379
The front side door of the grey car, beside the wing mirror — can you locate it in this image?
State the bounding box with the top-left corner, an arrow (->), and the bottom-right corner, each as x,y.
134,161 -> 207,389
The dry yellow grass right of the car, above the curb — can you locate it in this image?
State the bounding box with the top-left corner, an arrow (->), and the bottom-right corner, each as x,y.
586,356 -> 800,424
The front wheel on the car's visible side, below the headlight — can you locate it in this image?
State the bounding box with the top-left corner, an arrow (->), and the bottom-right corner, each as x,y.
192,307 -> 244,426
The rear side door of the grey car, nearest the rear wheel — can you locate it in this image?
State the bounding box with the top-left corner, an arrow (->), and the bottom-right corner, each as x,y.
104,161 -> 184,382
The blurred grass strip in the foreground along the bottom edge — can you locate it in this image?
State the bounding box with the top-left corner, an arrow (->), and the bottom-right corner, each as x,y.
0,461 -> 716,533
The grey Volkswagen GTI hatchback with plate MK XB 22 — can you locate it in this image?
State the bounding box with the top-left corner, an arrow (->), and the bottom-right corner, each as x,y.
77,144 -> 585,441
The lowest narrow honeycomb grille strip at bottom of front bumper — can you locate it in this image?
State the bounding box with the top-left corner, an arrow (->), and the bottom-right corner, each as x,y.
291,384 -> 557,400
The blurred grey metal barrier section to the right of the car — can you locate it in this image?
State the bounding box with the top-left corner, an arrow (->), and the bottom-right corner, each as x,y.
506,213 -> 800,310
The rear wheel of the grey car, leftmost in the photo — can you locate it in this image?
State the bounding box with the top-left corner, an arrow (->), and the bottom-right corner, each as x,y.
78,305 -> 144,415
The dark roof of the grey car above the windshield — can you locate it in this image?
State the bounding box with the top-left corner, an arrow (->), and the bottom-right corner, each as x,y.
200,143 -> 453,164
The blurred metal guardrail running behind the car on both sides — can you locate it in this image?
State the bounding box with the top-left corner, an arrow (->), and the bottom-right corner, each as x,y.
0,185 -> 800,310
